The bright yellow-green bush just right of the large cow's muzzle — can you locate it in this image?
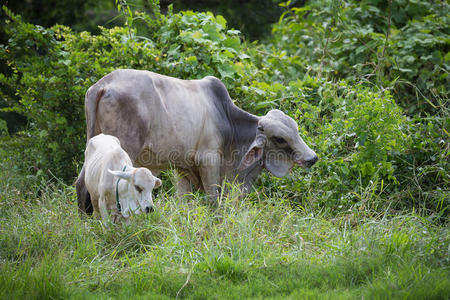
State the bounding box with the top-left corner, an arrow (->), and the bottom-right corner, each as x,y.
324,84 -> 408,181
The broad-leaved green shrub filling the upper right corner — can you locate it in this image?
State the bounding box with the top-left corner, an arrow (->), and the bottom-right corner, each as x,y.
269,0 -> 450,113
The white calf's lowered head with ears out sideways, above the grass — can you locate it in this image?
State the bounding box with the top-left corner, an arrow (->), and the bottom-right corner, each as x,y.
108,168 -> 161,218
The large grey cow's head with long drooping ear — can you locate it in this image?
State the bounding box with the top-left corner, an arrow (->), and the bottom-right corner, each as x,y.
240,109 -> 318,177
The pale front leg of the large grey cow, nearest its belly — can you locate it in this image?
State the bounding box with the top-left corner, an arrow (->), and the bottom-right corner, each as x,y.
200,154 -> 221,205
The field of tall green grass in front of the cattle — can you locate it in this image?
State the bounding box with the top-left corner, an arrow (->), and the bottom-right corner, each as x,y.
0,164 -> 450,299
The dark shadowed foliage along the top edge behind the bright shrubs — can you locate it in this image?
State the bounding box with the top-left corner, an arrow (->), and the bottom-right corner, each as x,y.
3,0 -> 284,40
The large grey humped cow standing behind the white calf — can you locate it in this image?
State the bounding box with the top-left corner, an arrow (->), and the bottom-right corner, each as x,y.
76,69 -> 317,213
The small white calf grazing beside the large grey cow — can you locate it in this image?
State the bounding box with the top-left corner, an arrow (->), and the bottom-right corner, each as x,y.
83,134 -> 161,222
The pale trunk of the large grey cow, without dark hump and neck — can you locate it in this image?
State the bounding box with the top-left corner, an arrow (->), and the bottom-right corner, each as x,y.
87,70 -> 222,170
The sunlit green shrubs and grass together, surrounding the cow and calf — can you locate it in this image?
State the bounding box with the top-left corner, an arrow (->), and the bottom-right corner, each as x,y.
0,0 -> 450,299
